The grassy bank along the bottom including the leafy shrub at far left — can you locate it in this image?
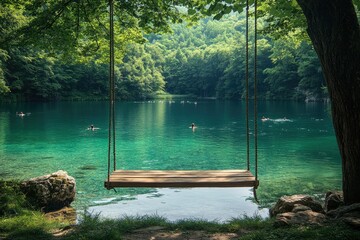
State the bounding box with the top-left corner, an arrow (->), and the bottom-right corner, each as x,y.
0,182 -> 360,240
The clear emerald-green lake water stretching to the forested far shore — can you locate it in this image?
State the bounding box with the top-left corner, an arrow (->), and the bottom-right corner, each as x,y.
0,101 -> 341,208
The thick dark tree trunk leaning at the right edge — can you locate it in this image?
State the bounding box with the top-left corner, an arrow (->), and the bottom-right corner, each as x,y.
297,0 -> 360,204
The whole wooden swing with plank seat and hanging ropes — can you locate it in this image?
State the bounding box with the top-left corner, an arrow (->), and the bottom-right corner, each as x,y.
104,0 -> 259,191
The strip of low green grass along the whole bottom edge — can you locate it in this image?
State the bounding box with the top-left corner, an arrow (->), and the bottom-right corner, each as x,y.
0,212 -> 360,240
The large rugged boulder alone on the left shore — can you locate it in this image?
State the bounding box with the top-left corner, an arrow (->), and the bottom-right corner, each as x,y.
20,170 -> 76,211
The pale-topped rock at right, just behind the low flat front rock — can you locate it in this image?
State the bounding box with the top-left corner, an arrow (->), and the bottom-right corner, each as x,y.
270,195 -> 324,217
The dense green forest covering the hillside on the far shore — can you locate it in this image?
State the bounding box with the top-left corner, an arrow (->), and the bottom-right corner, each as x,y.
0,1 -> 327,101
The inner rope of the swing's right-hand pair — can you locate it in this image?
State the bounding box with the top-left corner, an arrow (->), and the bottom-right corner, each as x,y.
245,0 -> 250,171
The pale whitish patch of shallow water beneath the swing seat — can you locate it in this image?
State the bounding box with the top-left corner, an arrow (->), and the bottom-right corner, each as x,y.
87,188 -> 269,222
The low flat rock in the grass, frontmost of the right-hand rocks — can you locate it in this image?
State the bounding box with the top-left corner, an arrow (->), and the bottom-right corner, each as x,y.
274,210 -> 327,226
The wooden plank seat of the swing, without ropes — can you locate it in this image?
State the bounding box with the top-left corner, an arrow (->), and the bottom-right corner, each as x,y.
105,170 -> 259,189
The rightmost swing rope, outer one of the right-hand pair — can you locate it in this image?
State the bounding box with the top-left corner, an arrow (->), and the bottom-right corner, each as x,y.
254,0 -> 258,184
